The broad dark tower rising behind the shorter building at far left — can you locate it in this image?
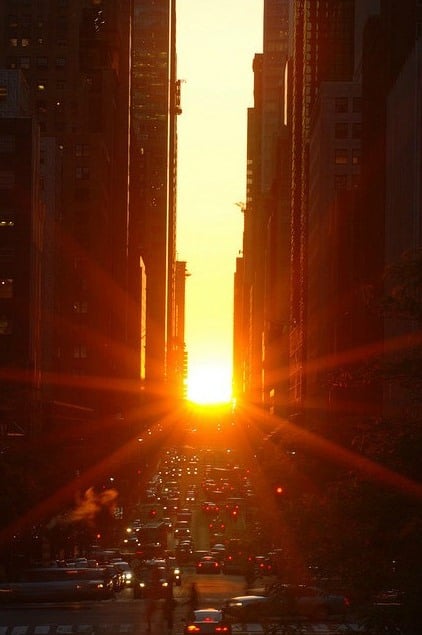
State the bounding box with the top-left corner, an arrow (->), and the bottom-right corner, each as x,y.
0,0 -> 131,428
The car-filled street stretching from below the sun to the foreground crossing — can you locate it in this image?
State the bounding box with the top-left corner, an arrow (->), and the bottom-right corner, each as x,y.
0,418 -> 408,635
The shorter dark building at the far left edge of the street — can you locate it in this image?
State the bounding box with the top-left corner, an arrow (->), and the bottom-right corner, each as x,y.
0,70 -> 45,437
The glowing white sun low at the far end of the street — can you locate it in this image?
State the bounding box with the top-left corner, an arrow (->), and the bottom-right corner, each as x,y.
188,364 -> 232,405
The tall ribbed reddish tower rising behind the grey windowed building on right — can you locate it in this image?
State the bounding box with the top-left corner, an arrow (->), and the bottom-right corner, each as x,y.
289,0 -> 354,416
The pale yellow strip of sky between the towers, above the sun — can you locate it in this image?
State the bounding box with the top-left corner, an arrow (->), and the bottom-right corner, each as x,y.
176,0 -> 263,400
